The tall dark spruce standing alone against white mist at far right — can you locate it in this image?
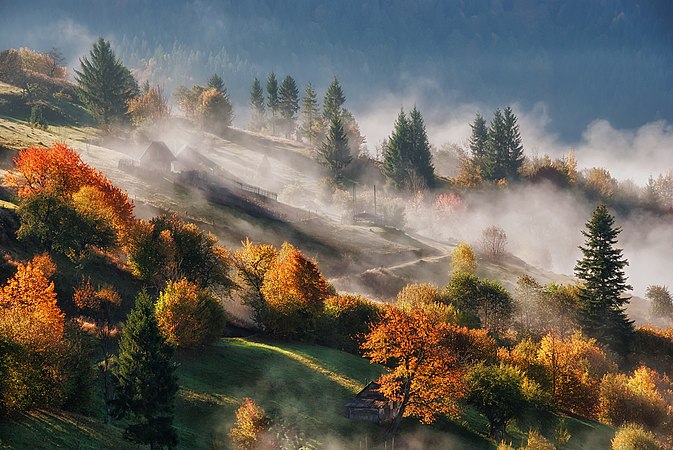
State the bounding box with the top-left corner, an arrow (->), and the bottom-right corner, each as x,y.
575,205 -> 633,353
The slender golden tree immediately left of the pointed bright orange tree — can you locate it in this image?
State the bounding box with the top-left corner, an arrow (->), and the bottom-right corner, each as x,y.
233,239 -> 278,326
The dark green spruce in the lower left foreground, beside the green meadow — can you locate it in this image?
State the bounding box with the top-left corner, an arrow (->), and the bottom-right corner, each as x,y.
113,291 -> 178,449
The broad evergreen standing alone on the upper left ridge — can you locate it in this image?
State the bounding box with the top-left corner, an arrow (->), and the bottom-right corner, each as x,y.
75,38 -> 139,127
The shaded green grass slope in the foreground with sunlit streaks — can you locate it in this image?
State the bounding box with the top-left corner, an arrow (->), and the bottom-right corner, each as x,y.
0,337 -> 613,450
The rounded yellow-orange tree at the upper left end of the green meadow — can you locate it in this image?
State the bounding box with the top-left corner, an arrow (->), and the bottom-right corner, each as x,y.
156,278 -> 226,348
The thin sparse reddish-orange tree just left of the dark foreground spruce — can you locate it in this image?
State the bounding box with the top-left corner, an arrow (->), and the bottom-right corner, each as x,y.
73,277 -> 121,422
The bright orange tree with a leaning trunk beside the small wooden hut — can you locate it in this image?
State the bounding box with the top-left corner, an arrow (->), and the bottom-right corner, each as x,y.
362,306 -> 466,434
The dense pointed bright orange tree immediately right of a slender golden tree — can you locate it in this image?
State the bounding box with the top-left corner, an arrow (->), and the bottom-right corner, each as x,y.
261,242 -> 330,339
